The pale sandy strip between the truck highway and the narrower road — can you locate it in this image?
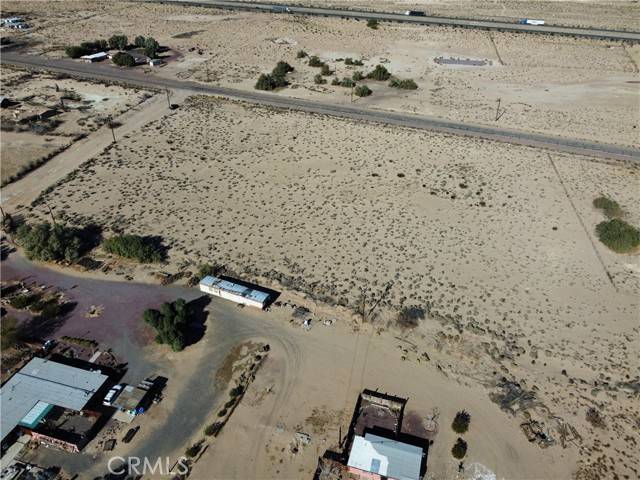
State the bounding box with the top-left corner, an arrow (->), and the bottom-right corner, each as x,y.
5,2 -> 640,145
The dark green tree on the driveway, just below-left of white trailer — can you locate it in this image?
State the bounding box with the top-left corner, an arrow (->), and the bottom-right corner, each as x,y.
142,298 -> 188,352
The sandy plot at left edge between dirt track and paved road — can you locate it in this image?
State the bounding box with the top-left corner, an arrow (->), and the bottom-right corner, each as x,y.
0,67 -> 151,184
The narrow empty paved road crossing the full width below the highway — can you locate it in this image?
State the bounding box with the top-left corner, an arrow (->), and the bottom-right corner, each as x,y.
0,53 -> 640,163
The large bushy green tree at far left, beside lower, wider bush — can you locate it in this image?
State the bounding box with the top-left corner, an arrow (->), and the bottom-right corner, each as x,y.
16,223 -> 90,262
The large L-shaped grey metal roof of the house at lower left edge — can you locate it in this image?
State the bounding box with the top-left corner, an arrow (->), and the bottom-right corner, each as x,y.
0,358 -> 108,439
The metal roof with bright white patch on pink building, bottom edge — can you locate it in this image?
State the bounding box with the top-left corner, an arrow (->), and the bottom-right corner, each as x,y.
347,433 -> 422,480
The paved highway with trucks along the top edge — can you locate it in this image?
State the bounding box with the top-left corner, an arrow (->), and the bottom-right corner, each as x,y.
135,0 -> 640,43
